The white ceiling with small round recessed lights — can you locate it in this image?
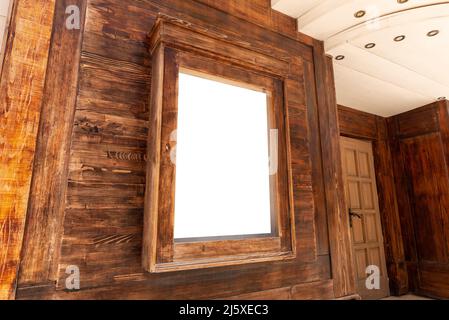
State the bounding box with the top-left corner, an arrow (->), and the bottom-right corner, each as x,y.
272,0 -> 449,117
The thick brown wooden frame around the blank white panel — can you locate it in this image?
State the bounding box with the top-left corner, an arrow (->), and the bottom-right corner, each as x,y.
143,17 -> 296,272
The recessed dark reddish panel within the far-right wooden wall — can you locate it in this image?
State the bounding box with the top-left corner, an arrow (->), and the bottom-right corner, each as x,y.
401,134 -> 449,263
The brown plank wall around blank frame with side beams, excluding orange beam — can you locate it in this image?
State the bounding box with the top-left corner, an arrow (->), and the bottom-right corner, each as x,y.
13,0 -> 355,299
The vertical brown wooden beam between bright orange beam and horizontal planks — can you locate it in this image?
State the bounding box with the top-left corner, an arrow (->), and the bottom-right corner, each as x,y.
20,0 -> 86,283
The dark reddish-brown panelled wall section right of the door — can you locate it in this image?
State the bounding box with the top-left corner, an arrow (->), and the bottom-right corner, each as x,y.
388,101 -> 449,298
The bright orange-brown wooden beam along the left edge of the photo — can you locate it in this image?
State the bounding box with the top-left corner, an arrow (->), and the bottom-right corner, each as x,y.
0,0 -> 55,299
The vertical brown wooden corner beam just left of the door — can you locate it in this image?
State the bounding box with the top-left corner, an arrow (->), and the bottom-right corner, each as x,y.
313,40 -> 356,298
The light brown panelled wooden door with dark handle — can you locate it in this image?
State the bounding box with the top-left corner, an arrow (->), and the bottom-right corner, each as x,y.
341,137 -> 390,299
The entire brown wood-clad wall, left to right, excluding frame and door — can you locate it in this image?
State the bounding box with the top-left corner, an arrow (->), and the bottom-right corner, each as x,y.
7,0 -> 449,299
